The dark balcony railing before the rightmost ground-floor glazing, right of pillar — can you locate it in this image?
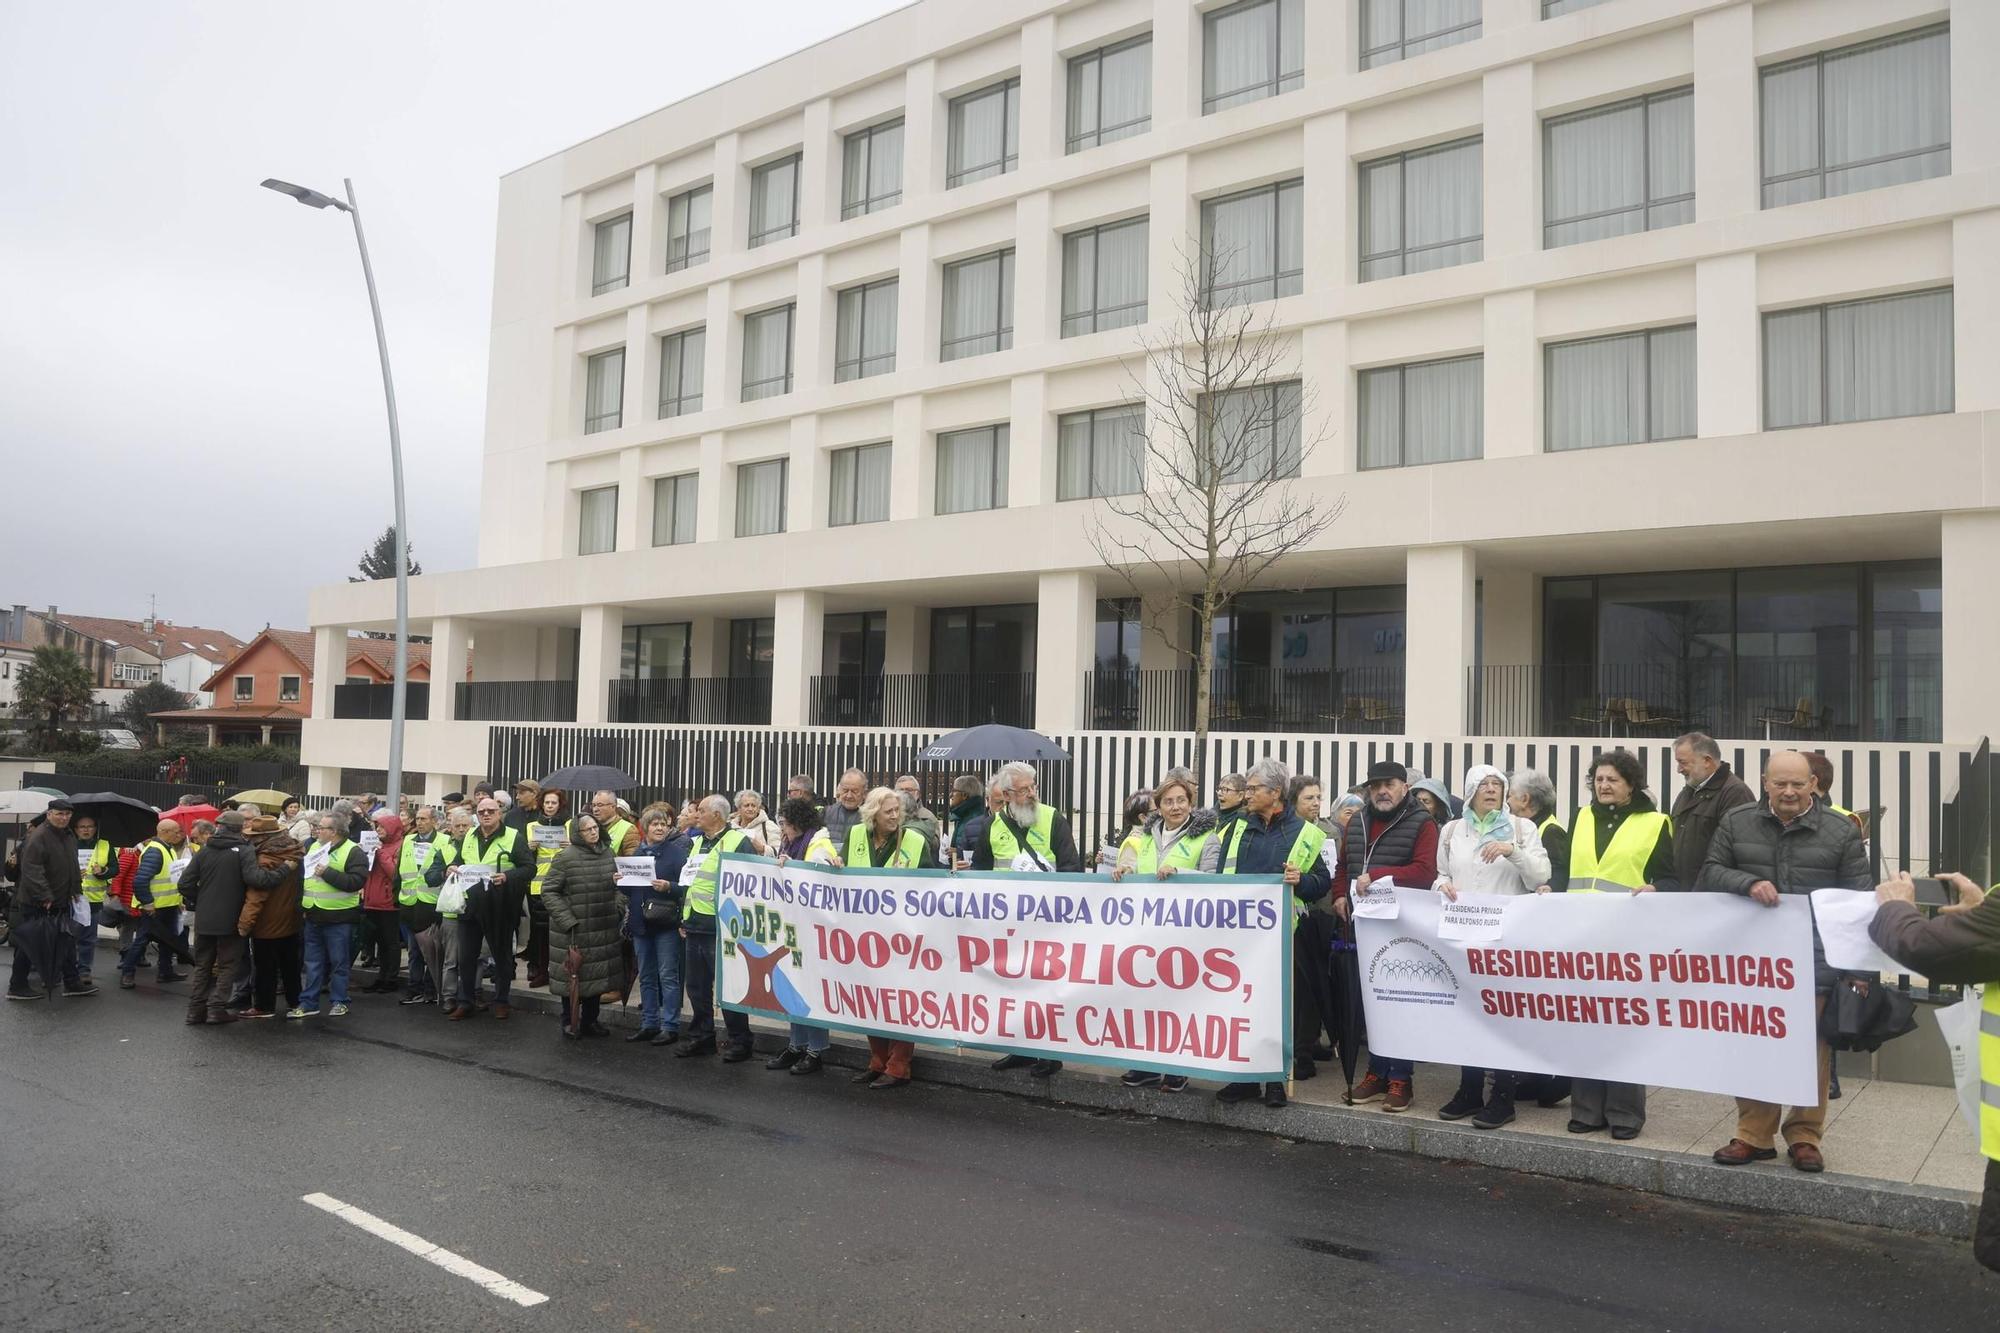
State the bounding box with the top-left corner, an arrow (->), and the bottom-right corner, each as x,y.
1466,654 -> 1944,743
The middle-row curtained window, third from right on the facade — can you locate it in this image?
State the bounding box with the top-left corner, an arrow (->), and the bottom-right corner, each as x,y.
1360,136 -> 1486,282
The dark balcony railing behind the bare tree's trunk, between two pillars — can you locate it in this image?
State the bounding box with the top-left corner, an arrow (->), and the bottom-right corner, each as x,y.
1084,667 -> 1404,735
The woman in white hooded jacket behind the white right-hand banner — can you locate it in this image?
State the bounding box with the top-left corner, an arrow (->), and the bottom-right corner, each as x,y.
1436,765 -> 1548,1129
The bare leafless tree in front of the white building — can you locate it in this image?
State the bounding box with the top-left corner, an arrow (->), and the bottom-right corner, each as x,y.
1088,246 -> 1346,740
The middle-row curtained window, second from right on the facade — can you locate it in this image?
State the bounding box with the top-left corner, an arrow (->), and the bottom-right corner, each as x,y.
1542,88 -> 1694,250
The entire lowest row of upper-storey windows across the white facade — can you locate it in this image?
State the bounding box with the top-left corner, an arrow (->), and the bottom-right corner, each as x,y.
578,288 -> 1954,554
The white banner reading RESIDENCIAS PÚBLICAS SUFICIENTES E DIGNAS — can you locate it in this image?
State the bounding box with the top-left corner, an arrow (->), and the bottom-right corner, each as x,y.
1354,889 -> 1818,1107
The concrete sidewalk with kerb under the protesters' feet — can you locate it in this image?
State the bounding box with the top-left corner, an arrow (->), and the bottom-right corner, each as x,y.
406,956 -> 1986,1237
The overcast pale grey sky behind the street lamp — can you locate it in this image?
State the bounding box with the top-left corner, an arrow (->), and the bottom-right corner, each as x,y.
0,0 -> 902,638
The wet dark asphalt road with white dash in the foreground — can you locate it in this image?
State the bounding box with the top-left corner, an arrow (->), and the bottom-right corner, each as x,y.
0,964 -> 2000,1333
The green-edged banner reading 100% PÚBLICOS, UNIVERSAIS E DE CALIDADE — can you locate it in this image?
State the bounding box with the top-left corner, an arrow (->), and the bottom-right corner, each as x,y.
716,853 -> 1292,1083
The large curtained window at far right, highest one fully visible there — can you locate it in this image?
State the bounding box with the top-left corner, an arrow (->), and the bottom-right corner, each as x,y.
1762,24 -> 1952,208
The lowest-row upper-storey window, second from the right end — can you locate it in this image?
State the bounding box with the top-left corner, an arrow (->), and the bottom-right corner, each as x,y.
1542,324 -> 1694,452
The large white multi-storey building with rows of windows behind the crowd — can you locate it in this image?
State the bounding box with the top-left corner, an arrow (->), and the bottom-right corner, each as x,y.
304,0 -> 2000,795
